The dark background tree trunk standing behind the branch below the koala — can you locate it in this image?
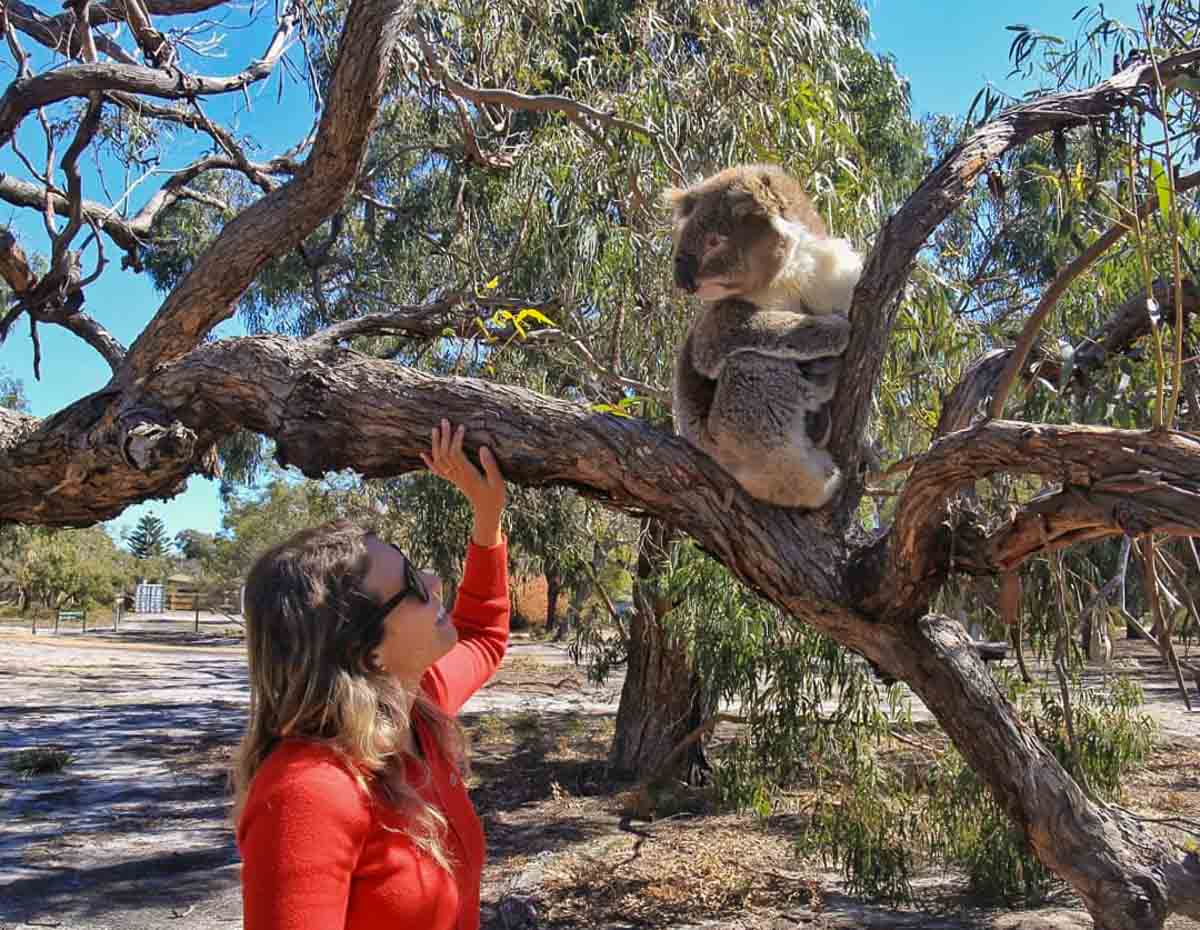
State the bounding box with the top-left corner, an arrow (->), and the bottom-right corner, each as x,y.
608,520 -> 714,782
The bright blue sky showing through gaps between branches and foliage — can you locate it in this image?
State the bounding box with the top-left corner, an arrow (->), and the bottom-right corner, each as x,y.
0,0 -> 1134,544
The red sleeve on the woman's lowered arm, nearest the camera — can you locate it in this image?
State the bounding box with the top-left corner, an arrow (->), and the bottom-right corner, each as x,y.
238,748 -> 371,930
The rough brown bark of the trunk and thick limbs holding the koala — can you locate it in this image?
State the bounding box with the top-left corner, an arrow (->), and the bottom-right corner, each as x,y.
0,14 -> 1200,930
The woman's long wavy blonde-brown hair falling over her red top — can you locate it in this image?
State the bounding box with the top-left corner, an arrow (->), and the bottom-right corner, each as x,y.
232,520 -> 467,870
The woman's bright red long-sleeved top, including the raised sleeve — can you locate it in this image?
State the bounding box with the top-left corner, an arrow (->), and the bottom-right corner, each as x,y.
238,542 -> 509,930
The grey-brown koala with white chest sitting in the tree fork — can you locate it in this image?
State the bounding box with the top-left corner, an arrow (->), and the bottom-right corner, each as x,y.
665,164 -> 863,509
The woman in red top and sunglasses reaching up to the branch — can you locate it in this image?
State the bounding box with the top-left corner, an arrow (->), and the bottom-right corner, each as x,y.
234,420 -> 509,930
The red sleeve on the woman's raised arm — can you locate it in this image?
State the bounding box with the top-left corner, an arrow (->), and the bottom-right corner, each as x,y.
422,542 -> 509,714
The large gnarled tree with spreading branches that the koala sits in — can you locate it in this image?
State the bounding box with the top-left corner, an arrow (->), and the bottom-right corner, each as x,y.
0,0 -> 1200,930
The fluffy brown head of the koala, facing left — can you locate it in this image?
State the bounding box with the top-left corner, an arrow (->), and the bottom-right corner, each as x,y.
664,164 -> 826,300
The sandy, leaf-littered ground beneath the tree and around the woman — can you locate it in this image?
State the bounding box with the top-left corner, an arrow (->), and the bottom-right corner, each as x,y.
0,620 -> 1200,930
